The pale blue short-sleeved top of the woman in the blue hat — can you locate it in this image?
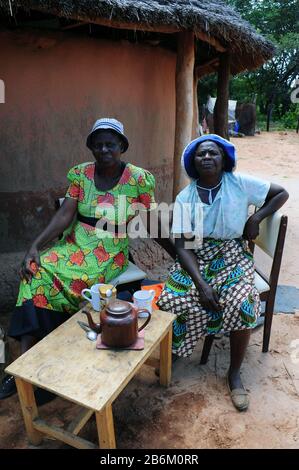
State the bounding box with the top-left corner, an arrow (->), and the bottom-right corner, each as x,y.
172,172 -> 270,240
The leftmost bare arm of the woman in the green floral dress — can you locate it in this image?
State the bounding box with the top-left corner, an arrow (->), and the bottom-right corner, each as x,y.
20,197 -> 78,281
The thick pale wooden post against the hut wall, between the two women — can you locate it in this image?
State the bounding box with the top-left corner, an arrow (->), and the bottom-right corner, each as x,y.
173,31 -> 194,199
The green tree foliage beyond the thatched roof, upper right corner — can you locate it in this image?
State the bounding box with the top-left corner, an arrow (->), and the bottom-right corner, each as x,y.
201,0 -> 299,125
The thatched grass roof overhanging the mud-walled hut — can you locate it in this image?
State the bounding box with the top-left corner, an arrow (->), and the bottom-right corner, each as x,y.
0,0 -> 274,73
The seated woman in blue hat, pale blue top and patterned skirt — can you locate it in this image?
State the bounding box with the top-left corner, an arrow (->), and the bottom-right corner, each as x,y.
158,134 -> 288,411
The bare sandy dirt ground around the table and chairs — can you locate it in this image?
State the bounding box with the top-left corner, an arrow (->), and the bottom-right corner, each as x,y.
0,132 -> 299,449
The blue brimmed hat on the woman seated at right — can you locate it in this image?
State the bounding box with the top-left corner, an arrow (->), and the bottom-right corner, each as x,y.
182,134 -> 237,179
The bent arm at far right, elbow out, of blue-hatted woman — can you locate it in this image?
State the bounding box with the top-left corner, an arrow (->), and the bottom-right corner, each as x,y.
243,183 -> 289,240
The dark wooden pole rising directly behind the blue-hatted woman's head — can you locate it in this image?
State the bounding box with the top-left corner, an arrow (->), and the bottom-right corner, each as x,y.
214,52 -> 230,139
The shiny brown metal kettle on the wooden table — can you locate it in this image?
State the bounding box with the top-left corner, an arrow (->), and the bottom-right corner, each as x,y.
82,300 -> 151,348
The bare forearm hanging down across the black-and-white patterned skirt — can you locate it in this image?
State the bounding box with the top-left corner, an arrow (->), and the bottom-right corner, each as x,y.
175,235 -> 221,311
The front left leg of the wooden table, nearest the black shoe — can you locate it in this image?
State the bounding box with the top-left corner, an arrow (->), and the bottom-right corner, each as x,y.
15,377 -> 42,446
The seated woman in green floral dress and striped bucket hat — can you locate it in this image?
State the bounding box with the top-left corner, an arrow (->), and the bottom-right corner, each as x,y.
0,118 -> 176,399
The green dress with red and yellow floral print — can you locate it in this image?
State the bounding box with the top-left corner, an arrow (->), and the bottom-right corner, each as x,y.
9,163 -> 155,337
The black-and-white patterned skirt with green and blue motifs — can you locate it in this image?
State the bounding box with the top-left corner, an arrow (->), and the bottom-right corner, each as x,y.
157,238 -> 260,357
